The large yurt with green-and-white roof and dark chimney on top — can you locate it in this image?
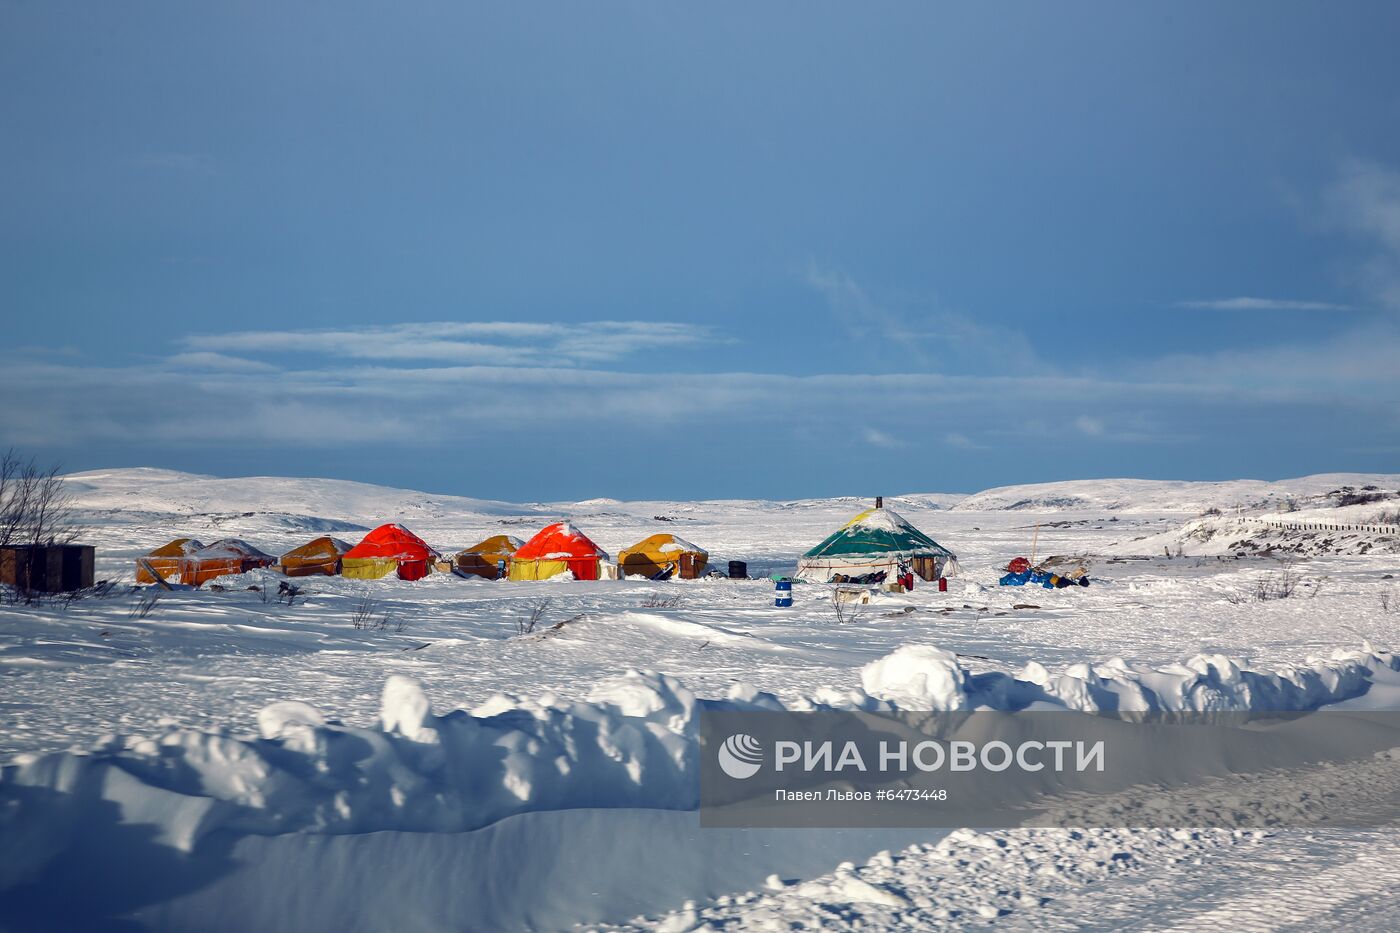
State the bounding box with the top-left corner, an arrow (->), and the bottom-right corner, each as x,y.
797,509 -> 958,583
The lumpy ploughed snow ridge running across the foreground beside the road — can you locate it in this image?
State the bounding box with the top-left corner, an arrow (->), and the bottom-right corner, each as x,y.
0,646 -> 1400,874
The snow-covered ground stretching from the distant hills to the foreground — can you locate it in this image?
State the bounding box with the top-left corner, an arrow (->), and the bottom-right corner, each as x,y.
0,469 -> 1400,930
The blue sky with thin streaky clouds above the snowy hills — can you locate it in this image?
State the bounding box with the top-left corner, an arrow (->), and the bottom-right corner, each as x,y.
0,1 -> 1400,500
